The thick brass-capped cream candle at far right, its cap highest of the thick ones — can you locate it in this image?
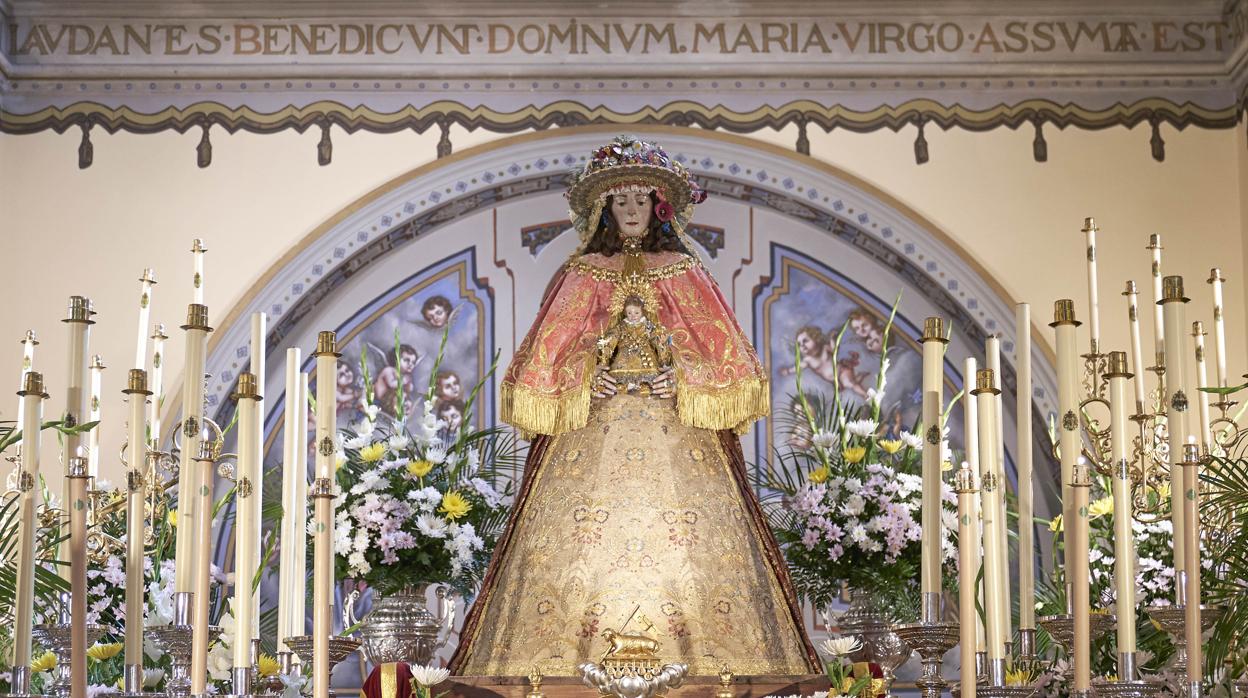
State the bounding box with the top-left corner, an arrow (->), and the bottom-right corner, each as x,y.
1159,276 -> 1191,606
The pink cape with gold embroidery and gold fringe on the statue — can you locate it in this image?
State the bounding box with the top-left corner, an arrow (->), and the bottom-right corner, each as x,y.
500,252 -> 769,435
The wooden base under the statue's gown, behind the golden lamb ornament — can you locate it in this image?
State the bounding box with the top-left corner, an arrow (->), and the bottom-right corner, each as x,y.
446,674 -> 829,698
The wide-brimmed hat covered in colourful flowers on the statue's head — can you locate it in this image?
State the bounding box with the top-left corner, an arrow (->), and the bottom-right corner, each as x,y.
568,136 -> 706,237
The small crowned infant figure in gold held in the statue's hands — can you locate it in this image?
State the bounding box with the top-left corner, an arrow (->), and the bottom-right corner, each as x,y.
598,296 -> 671,396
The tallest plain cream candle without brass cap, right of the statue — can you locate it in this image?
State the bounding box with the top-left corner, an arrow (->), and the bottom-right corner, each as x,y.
1015,303 -> 1036,656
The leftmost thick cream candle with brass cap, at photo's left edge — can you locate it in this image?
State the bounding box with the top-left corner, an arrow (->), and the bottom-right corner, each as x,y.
9,371 -> 47,694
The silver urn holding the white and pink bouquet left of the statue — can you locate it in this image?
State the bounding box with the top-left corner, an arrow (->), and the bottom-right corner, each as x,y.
343,584 -> 456,666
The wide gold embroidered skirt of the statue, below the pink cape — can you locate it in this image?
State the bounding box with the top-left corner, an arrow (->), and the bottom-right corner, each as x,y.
451,395 -> 820,676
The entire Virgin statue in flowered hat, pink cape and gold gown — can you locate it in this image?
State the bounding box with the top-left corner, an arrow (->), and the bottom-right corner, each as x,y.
451,136 -> 820,676
